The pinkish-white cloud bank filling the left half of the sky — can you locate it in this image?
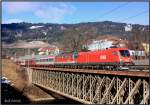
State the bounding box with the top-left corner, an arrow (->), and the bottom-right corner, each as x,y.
2,2 -> 76,22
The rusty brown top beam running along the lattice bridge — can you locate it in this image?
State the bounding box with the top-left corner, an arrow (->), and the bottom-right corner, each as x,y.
32,67 -> 150,77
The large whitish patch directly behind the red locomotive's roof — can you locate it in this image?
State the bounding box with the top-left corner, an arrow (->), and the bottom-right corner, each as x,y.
88,40 -> 113,51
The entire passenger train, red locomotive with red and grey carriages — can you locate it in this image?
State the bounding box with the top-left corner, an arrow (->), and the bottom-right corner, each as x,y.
16,48 -> 134,69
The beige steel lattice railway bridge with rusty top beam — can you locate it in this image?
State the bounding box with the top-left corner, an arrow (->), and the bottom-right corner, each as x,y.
27,67 -> 150,104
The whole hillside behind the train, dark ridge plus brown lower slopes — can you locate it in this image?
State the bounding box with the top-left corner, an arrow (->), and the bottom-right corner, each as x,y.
1,21 -> 149,57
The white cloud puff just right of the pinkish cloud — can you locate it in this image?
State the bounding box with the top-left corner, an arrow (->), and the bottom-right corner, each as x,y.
35,3 -> 76,22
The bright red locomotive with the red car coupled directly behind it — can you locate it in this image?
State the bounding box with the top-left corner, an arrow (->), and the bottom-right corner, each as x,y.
55,48 -> 133,69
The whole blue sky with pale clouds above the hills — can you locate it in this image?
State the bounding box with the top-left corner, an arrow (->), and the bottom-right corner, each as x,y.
2,2 -> 149,25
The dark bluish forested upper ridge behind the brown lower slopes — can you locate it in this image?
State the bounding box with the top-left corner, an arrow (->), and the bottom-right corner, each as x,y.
1,21 -> 148,44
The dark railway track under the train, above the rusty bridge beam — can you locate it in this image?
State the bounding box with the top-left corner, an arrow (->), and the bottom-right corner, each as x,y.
22,65 -> 150,71
